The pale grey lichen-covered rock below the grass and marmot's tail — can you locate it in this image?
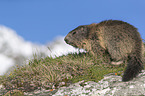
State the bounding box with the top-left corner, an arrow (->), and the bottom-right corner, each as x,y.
0,70 -> 145,96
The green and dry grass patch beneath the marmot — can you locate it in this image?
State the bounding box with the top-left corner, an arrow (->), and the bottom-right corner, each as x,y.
0,47 -> 144,92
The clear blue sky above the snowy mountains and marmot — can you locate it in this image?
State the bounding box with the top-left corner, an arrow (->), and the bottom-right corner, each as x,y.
0,0 -> 145,44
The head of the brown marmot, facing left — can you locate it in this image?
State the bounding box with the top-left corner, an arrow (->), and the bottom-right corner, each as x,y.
64,25 -> 88,48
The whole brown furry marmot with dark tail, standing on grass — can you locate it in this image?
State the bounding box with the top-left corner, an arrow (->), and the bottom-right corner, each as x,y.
65,20 -> 143,81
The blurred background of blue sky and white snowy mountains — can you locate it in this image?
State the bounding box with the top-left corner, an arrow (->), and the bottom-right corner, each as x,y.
0,0 -> 145,75
